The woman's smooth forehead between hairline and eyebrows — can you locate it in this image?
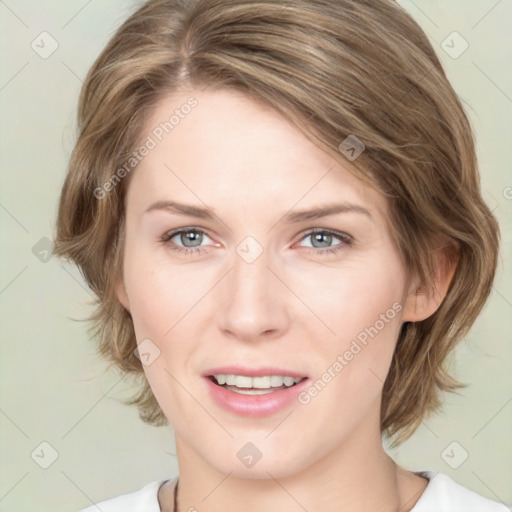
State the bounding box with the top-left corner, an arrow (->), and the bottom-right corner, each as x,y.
127,89 -> 386,222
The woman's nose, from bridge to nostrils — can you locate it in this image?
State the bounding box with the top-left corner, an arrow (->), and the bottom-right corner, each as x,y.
217,245 -> 291,342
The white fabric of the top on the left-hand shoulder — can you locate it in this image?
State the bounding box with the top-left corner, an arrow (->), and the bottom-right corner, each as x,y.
78,480 -> 174,512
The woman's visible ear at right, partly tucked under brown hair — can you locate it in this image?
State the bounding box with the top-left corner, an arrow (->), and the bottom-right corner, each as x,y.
402,239 -> 459,322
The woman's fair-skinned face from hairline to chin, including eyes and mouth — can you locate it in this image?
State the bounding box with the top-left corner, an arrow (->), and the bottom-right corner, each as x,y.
118,90 -> 420,478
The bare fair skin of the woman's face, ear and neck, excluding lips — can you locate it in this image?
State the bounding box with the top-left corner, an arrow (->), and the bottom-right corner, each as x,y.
117,89 -> 453,512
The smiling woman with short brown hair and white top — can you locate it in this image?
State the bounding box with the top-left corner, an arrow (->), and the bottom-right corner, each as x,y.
56,0 -> 507,512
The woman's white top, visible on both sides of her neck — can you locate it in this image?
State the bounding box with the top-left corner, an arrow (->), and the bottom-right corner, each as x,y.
79,471 -> 512,512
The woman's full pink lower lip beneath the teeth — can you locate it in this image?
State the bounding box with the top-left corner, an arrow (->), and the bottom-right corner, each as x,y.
205,377 -> 309,418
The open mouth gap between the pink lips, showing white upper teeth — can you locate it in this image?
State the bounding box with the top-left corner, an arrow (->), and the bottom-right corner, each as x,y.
208,373 -> 307,395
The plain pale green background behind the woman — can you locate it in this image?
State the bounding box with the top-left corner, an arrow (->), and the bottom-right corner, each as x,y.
0,0 -> 512,512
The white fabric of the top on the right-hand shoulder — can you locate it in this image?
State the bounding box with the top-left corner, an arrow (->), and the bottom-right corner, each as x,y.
411,471 -> 510,512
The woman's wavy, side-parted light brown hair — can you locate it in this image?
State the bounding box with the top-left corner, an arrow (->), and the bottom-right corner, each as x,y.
55,0 -> 499,445
